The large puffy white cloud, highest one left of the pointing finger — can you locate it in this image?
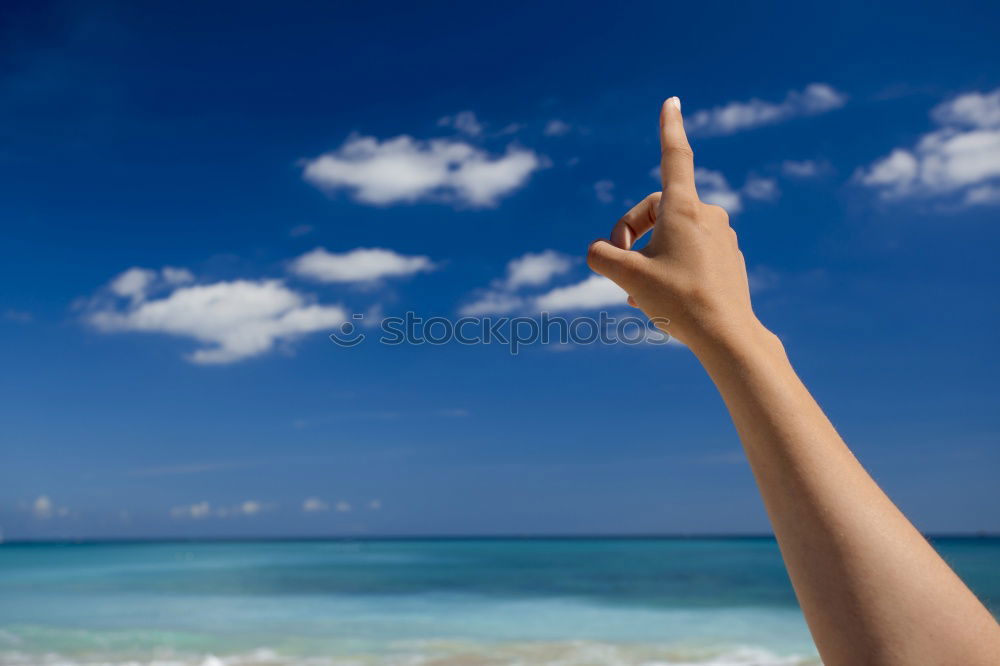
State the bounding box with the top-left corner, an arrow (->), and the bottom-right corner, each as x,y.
303,135 -> 542,207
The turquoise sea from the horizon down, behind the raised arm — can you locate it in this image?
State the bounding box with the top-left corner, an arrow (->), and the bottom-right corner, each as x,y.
0,538 -> 1000,666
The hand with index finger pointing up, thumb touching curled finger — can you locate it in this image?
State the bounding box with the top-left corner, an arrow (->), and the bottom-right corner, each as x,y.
587,97 -> 762,353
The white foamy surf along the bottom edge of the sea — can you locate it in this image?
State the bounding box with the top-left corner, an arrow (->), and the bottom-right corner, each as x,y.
0,641 -> 820,666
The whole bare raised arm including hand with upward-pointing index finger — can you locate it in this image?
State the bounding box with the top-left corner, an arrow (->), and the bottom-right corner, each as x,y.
588,97 -> 1000,666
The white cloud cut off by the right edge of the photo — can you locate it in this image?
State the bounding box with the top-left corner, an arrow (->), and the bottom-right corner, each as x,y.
856,89 -> 1000,206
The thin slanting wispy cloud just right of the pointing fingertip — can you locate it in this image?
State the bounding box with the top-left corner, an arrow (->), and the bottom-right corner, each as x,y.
685,83 -> 847,136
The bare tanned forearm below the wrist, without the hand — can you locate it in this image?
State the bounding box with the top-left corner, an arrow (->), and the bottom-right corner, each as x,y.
692,325 -> 1000,665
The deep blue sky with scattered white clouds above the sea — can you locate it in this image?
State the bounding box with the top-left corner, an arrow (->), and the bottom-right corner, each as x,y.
0,2 -> 1000,538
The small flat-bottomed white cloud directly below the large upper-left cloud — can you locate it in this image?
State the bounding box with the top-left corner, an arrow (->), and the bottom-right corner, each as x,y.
289,247 -> 434,282
